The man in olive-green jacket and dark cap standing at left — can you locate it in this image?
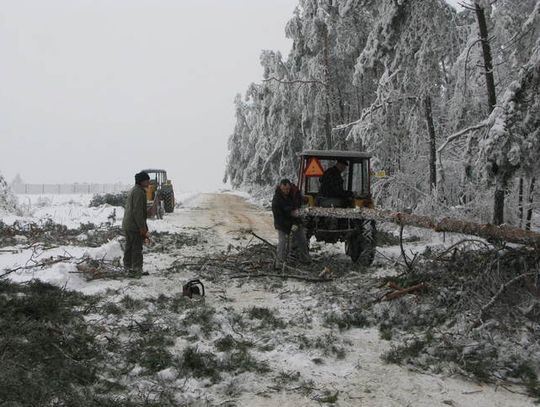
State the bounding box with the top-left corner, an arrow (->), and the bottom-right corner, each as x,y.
122,172 -> 150,275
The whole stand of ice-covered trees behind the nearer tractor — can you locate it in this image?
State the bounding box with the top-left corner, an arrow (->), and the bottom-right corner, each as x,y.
226,0 -> 540,226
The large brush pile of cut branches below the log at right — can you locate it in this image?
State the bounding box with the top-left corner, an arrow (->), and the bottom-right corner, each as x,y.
366,240 -> 540,395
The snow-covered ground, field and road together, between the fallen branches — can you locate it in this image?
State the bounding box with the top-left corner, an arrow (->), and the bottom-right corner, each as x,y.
0,193 -> 533,407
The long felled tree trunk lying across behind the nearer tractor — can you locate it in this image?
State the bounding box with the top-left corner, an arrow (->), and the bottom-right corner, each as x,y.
301,208 -> 540,249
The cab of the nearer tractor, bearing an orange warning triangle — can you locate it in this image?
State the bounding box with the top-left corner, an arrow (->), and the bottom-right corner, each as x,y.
298,150 -> 373,208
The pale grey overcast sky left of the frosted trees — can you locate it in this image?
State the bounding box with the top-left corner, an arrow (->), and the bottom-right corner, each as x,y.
0,0 -> 457,190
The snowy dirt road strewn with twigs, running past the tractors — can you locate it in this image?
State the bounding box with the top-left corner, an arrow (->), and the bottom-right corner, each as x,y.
144,194 -> 532,407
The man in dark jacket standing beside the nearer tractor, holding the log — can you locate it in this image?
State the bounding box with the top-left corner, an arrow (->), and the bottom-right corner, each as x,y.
272,179 -> 311,268
